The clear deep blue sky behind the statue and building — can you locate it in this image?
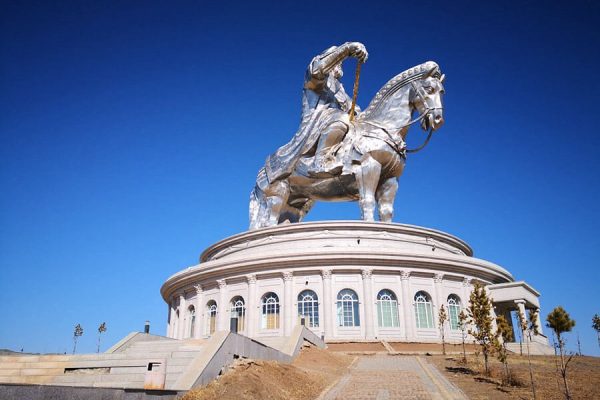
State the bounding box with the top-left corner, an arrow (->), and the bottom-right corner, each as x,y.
0,0 -> 600,355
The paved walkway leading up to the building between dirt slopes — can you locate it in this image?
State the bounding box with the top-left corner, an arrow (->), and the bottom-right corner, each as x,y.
322,355 -> 467,400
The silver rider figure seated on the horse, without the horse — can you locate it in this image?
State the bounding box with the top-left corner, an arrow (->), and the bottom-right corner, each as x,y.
265,42 -> 368,183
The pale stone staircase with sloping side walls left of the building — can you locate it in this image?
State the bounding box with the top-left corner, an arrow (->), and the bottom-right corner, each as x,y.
0,326 -> 325,399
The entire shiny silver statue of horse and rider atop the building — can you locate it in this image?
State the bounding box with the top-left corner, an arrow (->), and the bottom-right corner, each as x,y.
249,42 -> 444,229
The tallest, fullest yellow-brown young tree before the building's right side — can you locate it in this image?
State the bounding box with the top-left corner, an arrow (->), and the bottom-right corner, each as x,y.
467,282 -> 495,375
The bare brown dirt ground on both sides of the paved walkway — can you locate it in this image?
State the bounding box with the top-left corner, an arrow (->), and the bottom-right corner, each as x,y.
182,343 -> 600,400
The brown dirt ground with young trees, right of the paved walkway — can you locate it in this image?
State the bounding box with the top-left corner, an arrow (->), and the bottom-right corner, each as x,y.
427,355 -> 600,400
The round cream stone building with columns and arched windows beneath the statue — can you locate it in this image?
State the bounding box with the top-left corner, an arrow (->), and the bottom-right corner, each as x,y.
161,221 -> 548,346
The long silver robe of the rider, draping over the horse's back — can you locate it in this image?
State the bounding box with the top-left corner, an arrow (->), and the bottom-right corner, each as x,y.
265,56 -> 352,182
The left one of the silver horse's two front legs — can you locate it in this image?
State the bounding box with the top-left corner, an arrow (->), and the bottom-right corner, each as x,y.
353,154 -> 381,221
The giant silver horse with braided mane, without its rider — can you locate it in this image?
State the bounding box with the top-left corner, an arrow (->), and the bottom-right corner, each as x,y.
249,61 -> 444,229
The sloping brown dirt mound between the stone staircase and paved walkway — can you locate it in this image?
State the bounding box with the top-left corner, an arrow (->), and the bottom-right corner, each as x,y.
181,347 -> 354,400
